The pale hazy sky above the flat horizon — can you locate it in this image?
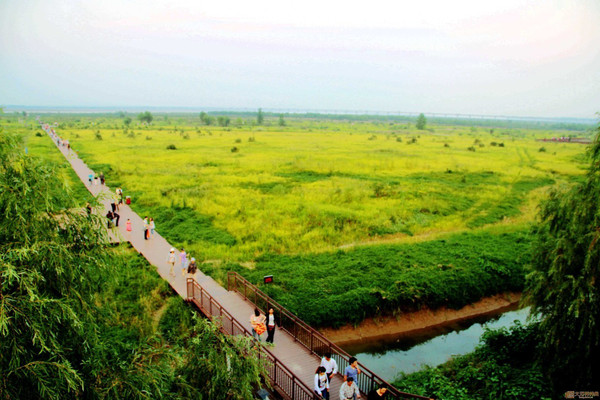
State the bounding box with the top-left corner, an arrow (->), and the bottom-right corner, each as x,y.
0,0 -> 600,118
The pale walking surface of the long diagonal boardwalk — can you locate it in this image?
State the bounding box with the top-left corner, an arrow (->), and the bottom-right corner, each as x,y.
41,127 -> 343,399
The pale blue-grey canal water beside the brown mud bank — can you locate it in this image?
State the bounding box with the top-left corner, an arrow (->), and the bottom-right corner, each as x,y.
342,308 -> 529,382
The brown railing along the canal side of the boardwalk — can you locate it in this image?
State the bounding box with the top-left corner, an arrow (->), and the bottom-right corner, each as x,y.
227,271 -> 430,400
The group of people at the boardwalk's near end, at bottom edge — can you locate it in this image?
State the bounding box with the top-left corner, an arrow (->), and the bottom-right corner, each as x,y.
314,353 -> 388,400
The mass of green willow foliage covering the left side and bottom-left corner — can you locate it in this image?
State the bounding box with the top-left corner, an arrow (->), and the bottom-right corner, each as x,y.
0,130 -> 264,399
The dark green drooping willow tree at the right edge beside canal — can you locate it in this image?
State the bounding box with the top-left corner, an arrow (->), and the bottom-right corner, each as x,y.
525,123 -> 600,392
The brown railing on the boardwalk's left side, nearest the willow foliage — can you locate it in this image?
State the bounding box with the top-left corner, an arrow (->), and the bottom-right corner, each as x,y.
187,278 -> 315,400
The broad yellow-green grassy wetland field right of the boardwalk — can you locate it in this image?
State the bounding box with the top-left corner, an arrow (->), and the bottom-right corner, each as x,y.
9,114 -> 589,327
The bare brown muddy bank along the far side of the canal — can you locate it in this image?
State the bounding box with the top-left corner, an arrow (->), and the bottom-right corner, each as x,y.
321,293 -> 521,345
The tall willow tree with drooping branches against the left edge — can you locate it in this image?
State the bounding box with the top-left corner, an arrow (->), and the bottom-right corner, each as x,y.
0,134 -> 103,399
